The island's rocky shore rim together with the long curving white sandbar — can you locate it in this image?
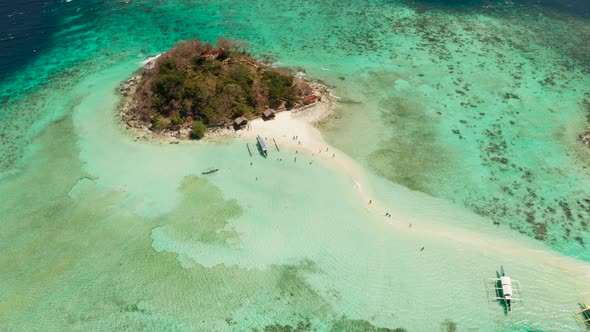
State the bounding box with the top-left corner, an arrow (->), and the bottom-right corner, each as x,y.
114,58 -> 590,290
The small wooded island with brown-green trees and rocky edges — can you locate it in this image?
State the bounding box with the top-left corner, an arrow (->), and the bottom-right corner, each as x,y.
121,38 -> 328,139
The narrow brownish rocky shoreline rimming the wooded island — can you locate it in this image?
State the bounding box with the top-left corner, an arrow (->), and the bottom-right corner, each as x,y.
118,56 -> 337,144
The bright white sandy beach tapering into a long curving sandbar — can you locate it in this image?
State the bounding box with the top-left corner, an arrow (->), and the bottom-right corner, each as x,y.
217,101 -> 590,279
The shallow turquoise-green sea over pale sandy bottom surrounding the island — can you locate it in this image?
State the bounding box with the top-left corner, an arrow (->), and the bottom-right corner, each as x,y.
0,0 -> 590,331
